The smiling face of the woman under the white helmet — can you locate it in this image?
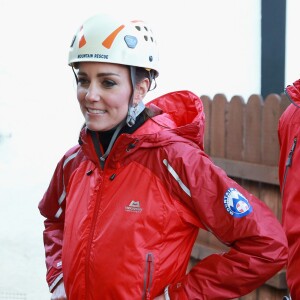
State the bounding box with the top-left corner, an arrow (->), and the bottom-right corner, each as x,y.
77,62 -> 132,131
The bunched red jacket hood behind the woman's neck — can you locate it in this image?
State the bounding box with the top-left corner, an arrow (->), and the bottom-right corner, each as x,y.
146,90 -> 205,150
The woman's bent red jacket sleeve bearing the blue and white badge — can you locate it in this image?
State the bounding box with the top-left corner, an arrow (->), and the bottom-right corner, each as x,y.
168,151 -> 287,300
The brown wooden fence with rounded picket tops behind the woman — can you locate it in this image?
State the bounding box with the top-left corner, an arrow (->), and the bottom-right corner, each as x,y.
190,94 -> 289,300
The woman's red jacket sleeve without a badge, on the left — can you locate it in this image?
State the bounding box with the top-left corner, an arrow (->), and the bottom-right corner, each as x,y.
38,148 -> 78,292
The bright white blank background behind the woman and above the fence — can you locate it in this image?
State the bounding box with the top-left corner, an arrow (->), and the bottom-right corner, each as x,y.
0,0 -> 300,300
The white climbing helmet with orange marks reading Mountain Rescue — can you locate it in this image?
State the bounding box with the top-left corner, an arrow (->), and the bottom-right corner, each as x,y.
68,14 -> 159,77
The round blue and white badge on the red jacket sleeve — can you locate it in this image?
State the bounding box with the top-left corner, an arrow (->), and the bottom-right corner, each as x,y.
224,188 -> 252,218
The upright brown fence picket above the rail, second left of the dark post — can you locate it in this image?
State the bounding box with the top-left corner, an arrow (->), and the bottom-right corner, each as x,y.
225,96 -> 245,160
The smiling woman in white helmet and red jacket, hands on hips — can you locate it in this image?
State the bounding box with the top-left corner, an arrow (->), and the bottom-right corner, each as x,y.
39,15 -> 287,300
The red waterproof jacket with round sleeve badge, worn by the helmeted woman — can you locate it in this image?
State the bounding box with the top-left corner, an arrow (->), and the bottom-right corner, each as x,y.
39,91 -> 287,300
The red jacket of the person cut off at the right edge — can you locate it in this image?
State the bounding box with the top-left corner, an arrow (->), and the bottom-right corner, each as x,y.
278,80 -> 300,300
